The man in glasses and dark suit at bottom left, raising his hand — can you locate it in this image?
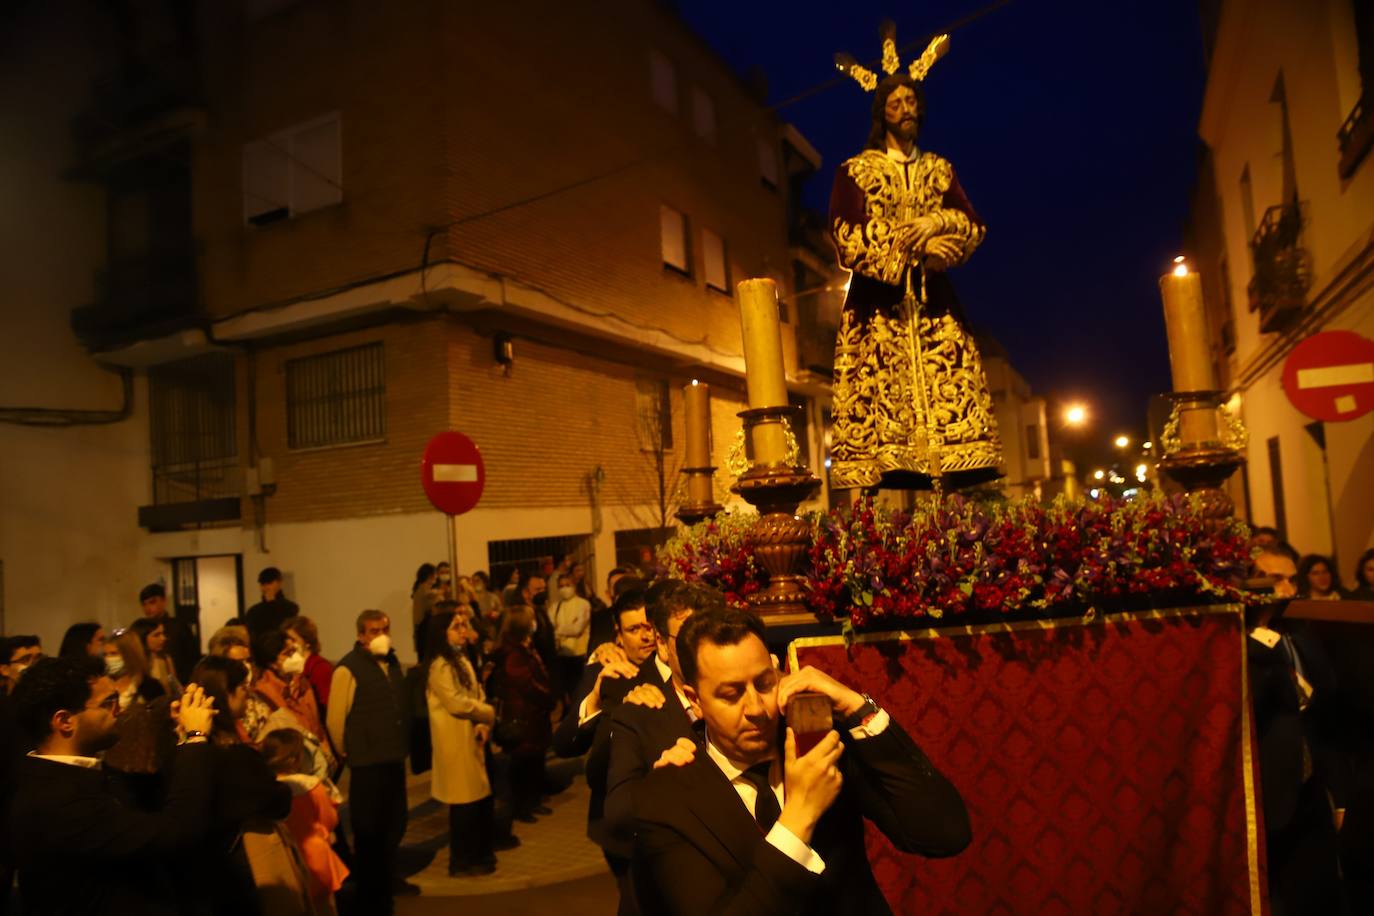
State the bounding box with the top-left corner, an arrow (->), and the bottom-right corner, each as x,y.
10,658 -> 214,916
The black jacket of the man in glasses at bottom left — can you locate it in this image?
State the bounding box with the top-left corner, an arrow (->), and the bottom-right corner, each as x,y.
10,744 -> 214,916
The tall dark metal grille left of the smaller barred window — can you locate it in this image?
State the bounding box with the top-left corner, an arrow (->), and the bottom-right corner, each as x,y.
148,353 -> 242,505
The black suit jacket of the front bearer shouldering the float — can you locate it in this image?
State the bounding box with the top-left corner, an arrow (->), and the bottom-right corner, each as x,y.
633,722 -> 971,916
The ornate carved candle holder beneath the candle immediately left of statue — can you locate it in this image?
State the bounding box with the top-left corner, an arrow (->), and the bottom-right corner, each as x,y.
732,407 -> 820,621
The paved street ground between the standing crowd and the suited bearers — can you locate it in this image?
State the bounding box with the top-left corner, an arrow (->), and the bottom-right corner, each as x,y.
397,761 -> 617,916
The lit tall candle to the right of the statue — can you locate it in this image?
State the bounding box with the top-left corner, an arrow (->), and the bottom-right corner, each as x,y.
1160,260 -> 1219,446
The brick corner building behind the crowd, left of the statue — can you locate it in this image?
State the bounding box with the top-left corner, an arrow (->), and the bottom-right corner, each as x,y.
3,0 -> 833,654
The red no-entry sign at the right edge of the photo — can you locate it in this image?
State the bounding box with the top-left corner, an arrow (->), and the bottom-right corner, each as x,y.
1283,331 -> 1374,423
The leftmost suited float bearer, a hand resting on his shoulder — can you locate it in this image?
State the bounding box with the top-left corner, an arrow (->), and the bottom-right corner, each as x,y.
554,589 -> 673,913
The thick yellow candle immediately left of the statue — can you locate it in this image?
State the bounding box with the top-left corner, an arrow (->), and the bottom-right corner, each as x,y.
735,277 -> 787,464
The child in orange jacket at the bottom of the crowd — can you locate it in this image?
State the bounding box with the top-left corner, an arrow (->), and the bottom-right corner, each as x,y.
262,728 -> 348,913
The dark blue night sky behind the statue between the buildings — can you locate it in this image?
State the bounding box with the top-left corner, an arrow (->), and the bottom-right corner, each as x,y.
679,0 -> 1205,466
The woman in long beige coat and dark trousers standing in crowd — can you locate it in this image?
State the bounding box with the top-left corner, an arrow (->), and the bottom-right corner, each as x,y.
425,608 -> 496,876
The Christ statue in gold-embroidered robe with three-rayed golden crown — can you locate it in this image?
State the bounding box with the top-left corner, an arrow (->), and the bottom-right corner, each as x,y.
830,23 -> 1003,489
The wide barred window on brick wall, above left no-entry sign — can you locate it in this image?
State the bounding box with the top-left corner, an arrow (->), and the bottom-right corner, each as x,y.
286,343 -> 386,449
